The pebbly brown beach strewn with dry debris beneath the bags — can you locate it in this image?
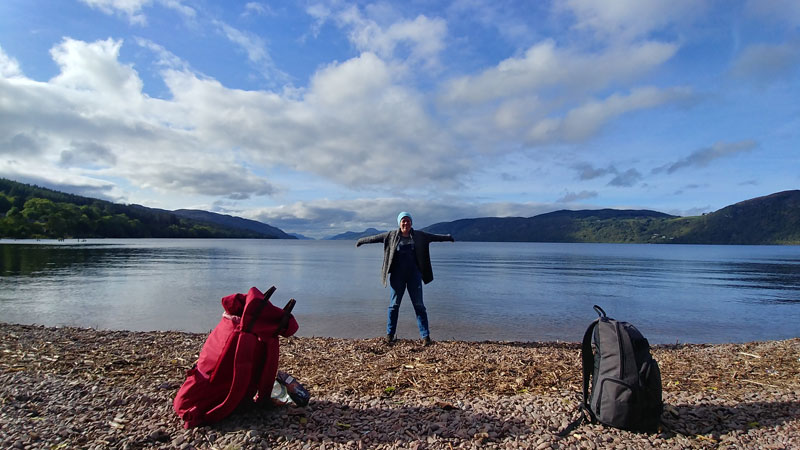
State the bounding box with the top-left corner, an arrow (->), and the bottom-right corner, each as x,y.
0,323 -> 800,449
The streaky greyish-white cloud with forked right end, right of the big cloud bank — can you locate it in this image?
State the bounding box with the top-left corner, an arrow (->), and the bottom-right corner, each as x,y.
439,40 -> 689,152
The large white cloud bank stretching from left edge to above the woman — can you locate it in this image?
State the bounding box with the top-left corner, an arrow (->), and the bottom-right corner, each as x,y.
0,39 -> 468,198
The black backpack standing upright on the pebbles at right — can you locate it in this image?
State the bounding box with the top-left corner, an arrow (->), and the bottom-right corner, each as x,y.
581,305 -> 664,431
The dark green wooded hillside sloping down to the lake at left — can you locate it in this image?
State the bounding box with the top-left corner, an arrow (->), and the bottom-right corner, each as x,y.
0,178 -> 293,239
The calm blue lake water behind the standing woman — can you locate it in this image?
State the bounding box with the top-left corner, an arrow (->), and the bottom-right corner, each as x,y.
0,239 -> 800,343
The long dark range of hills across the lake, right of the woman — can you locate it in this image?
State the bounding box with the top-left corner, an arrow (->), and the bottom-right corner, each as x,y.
423,190 -> 800,244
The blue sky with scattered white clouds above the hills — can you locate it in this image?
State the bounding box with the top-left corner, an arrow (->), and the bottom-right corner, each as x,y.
0,0 -> 800,238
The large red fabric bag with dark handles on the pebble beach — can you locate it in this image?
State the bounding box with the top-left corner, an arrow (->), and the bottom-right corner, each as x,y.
172,286 -> 298,428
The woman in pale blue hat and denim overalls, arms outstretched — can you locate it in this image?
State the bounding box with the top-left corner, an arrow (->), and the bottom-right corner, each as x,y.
356,211 -> 455,345
